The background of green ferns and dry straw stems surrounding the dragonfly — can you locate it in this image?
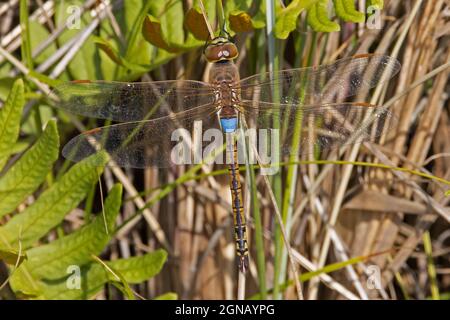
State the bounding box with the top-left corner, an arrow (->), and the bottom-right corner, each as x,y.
0,0 -> 450,299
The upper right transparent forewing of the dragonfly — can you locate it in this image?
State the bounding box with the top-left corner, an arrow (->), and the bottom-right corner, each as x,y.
239,54 -> 400,107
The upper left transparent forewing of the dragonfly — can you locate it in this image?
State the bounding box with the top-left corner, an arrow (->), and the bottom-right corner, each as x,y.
53,80 -> 214,122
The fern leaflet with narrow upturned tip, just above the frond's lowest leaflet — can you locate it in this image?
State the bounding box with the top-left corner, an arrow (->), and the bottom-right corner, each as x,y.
20,184 -> 122,279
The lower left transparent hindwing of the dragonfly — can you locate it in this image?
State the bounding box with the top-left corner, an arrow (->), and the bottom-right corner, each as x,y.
62,105 -> 219,168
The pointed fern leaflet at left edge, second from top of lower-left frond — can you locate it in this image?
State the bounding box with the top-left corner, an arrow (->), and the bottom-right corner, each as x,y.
0,120 -> 59,217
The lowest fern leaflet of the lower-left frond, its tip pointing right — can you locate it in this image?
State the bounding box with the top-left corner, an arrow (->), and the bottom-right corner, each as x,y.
22,249 -> 167,300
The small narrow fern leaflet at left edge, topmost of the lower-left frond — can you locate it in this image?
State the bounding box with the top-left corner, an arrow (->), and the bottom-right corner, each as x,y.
0,79 -> 25,170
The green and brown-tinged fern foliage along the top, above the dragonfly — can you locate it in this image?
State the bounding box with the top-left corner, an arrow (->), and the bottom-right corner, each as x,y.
89,0 -> 382,79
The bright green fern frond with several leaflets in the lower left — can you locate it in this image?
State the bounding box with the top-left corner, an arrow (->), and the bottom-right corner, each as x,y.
0,80 -> 167,299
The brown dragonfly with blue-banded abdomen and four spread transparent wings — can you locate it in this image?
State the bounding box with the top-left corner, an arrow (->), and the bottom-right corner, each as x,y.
53,34 -> 400,273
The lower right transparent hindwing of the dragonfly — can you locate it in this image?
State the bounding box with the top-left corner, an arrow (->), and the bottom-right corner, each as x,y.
242,101 -> 396,156
